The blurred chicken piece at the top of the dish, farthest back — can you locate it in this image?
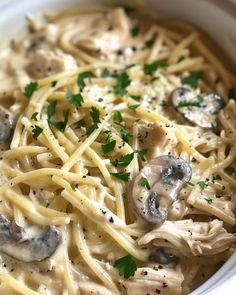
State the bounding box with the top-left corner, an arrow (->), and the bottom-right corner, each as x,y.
77,8 -> 130,54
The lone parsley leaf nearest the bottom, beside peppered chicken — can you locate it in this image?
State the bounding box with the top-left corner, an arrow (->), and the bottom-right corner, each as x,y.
114,255 -> 137,279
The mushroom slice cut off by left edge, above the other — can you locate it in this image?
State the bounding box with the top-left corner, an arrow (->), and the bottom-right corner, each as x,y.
0,106 -> 15,150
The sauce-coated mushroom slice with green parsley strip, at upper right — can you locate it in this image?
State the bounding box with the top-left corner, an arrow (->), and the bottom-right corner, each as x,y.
171,87 -> 225,128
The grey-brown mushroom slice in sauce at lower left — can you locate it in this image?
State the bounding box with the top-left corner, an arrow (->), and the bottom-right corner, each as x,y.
0,215 -> 61,262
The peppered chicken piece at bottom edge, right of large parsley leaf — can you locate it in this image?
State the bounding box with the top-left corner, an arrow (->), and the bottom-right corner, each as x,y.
120,266 -> 184,295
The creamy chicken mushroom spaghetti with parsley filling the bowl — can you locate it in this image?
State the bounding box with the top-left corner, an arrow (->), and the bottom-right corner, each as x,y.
0,6 -> 236,295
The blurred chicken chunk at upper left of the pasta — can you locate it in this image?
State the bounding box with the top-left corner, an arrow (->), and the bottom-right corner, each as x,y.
32,49 -> 77,77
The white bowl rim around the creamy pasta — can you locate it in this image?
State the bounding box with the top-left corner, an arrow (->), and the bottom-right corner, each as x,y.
0,0 -> 236,295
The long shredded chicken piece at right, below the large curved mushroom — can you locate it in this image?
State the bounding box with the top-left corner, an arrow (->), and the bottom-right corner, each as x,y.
138,219 -> 236,256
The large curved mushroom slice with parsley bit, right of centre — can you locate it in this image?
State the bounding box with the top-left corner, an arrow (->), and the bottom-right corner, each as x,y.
130,155 -> 192,226
